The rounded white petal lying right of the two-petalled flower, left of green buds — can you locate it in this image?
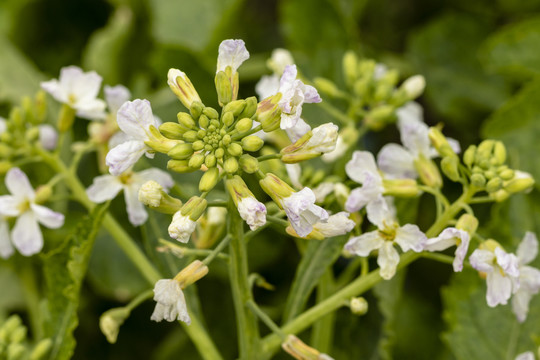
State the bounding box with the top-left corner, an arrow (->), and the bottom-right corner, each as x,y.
377,144 -> 418,179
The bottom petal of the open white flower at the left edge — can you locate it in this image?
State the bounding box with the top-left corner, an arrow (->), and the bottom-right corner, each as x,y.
11,211 -> 43,256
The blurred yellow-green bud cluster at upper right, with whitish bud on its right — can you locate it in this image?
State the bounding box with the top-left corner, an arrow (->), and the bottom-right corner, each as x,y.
314,51 -> 426,130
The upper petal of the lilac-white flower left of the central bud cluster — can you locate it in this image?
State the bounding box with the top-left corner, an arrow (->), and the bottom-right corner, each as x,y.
116,99 -> 157,141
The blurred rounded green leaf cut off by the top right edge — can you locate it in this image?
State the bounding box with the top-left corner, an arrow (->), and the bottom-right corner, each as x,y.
480,16 -> 540,79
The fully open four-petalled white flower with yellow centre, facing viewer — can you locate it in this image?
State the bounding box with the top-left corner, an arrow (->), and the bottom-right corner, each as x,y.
345,197 -> 427,280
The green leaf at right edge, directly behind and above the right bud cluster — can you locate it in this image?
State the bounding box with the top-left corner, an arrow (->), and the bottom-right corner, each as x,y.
482,80 -> 540,186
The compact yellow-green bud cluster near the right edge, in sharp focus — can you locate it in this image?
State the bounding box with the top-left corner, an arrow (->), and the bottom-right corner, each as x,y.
463,140 -> 534,201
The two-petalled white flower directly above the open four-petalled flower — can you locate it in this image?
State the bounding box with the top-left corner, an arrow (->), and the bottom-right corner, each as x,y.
345,151 -> 384,212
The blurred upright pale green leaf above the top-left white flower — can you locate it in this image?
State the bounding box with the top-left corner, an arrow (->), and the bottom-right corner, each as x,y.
82,6 -> 133,84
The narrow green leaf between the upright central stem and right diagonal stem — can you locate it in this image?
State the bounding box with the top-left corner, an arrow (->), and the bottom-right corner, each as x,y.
283,236 -> 347,323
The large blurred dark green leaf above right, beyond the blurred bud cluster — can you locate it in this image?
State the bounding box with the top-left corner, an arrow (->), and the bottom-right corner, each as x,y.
407,13 -> 509,128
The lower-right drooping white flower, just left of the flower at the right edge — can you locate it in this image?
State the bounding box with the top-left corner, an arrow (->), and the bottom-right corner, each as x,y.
469,246 -> 519,307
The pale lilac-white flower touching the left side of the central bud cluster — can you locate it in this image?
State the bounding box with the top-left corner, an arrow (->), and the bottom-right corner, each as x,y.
105,99 -> 158,175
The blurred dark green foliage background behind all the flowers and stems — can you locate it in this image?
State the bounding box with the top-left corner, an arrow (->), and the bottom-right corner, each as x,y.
0,0 -> 540,360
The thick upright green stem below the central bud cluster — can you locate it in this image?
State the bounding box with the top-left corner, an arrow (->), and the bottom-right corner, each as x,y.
227,199 -> 261,360
